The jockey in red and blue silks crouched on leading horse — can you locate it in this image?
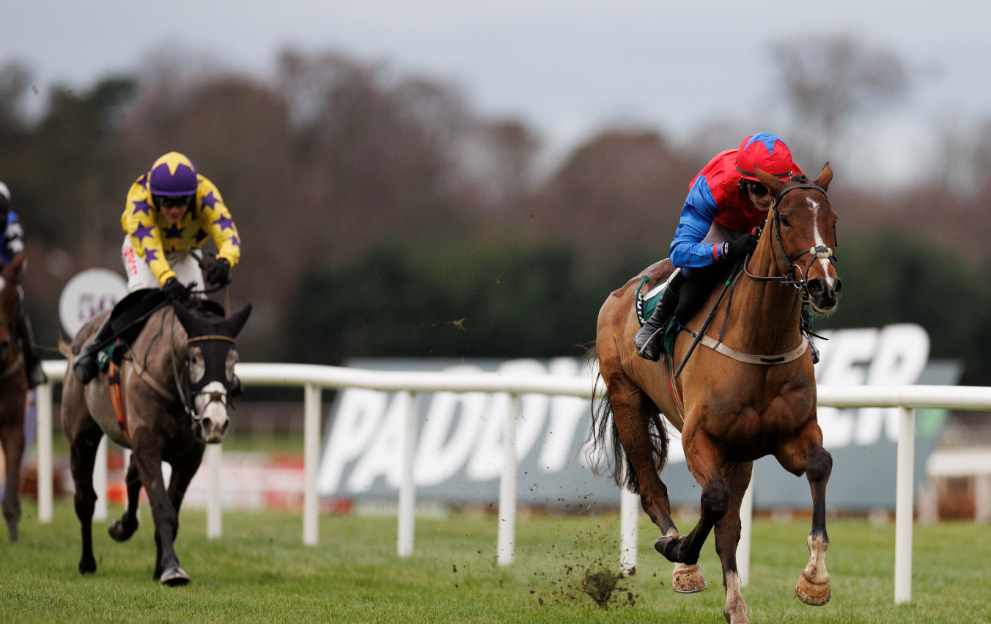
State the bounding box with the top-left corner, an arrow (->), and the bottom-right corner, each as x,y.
634,132 -> 802,362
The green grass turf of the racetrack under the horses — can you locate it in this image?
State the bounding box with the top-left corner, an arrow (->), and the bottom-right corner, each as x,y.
0,503 -> 991,624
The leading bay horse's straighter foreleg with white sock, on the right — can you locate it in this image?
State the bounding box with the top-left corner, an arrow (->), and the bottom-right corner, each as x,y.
777,420 -> 833,606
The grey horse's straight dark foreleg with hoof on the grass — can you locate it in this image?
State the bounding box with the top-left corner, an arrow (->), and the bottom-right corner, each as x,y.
131,427 -> 189,587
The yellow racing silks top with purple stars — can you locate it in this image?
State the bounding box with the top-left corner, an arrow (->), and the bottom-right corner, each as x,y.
120,174 -> 241,284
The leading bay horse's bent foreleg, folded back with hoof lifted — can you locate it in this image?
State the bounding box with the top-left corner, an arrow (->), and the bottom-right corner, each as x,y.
654,429 -> 730,564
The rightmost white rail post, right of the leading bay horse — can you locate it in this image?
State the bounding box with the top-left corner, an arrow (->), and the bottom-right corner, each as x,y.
895,407 -> 915,605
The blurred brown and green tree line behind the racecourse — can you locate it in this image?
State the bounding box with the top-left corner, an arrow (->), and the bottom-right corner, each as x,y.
0,39 -> 991,384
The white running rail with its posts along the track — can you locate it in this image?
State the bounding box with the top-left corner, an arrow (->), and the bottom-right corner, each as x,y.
37,360 -> 991,604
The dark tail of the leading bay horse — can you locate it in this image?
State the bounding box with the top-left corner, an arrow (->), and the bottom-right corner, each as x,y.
585,343 -> 668,494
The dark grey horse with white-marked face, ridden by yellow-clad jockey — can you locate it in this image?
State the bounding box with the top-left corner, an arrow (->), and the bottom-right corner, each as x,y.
62,298 -> 251,586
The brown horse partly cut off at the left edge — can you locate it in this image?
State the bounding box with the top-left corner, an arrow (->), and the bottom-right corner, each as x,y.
0,253 -> 28,542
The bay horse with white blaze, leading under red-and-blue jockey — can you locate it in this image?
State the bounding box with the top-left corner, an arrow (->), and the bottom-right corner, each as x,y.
590,164 -> 841,624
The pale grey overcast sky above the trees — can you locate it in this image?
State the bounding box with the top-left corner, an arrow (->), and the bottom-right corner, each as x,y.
0,0 -> 991,180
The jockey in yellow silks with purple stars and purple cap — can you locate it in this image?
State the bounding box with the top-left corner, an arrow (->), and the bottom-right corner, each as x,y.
74,152 -> 241,384
